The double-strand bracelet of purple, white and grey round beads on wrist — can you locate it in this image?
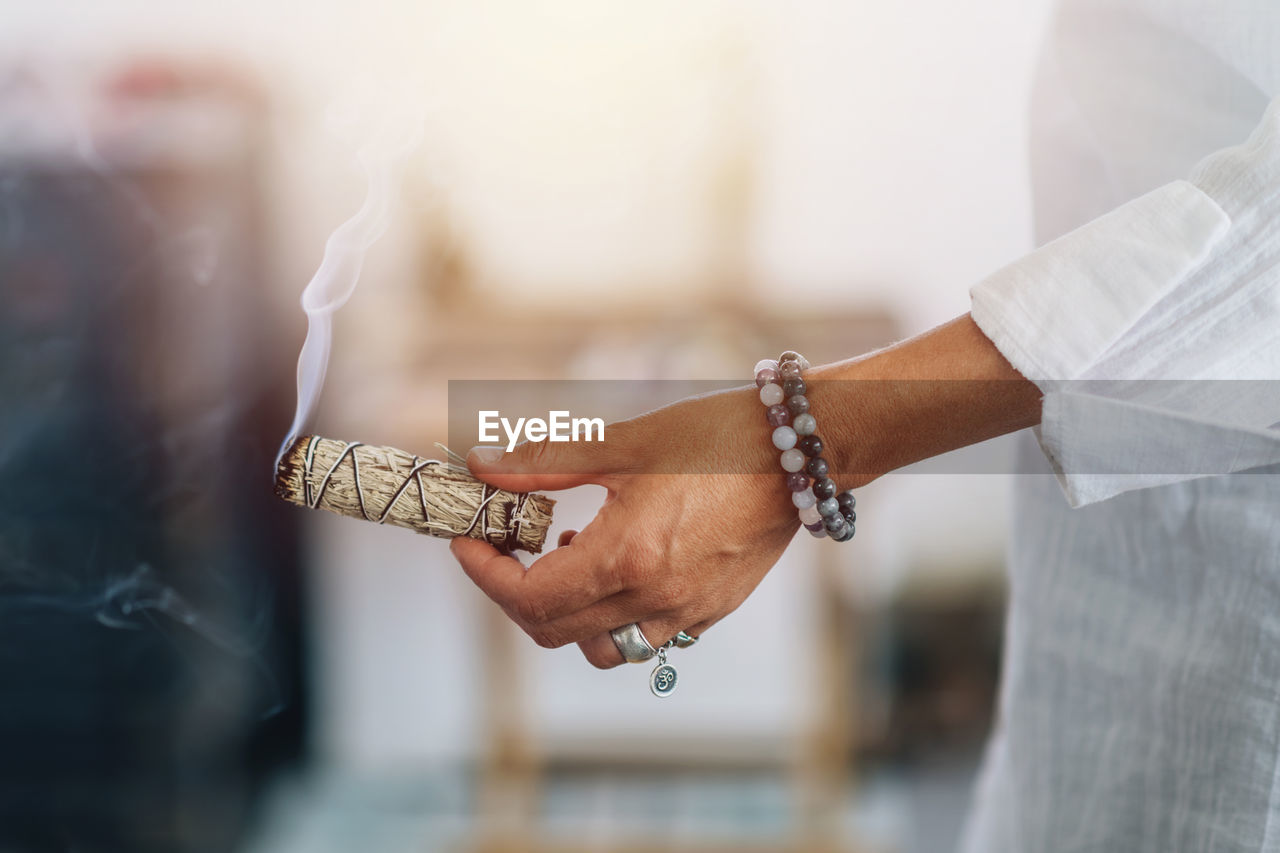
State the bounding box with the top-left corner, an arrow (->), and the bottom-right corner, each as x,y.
755,350 -> 858,542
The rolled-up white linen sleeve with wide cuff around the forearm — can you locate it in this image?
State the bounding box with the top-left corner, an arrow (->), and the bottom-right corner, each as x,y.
972,99 -> 1280,506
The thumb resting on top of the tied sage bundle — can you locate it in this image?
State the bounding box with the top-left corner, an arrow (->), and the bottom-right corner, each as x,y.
467,427 -> 630,492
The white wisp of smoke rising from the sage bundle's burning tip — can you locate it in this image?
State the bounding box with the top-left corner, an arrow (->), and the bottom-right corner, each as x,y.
275,103 -> 424,465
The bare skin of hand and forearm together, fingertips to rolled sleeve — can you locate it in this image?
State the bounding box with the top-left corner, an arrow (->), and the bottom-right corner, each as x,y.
452,315 -> 1041,667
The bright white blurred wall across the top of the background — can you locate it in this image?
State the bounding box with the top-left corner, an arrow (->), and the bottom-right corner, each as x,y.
0,0 -> 1050,328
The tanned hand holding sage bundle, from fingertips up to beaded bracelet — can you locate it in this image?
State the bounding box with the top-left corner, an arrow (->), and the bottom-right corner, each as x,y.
451,387 -> 799,669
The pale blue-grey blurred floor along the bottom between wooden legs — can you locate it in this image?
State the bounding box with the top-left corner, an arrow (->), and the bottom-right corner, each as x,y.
242,752 -> 978,853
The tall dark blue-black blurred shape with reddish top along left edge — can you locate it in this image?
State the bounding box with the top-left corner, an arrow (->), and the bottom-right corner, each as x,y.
0,63 -> 306,853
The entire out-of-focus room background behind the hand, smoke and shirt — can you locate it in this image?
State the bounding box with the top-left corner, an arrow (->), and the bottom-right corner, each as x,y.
0,0 -> 1048,853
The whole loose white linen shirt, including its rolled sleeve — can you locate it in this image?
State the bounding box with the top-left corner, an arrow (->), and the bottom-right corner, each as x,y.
964,0 -> 1280,853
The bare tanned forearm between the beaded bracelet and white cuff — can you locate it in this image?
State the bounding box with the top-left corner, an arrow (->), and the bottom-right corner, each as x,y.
805,314 -> 1041,487
